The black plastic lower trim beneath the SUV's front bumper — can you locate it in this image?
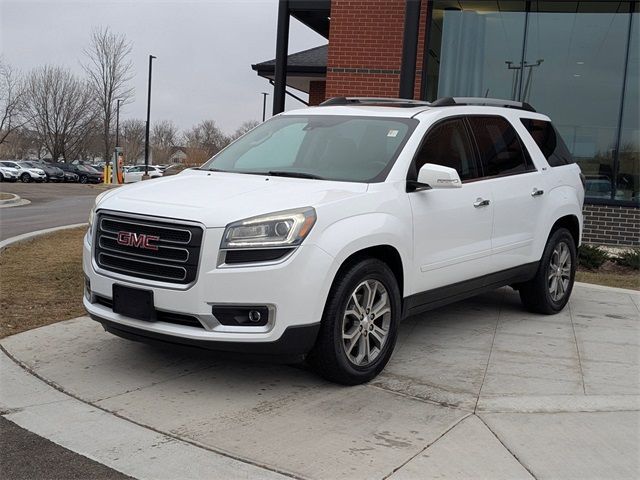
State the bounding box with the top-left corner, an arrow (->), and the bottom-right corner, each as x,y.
90,313 -> 320,357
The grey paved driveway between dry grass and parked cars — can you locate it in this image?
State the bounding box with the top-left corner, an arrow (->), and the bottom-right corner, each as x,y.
0,182 -> 104,240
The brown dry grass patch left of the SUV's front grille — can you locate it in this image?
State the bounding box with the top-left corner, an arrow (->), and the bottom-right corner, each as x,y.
0,227 -> 86,338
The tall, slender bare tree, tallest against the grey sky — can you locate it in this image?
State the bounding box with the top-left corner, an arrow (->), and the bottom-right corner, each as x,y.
83,27 -> 133,162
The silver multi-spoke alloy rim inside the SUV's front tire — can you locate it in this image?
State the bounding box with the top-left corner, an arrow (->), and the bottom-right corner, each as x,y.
342,280 -> 391,367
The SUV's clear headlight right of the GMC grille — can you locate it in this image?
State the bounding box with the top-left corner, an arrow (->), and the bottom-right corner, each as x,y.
220,207 -> 316,249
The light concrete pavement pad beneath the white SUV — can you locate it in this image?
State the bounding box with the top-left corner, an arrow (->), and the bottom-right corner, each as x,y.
0,285 -> 640,480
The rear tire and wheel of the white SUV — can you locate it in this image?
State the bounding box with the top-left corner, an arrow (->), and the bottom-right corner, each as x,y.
519,228 -> 578,315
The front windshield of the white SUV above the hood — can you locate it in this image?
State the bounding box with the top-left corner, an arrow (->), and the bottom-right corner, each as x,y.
202,115 -> 418,183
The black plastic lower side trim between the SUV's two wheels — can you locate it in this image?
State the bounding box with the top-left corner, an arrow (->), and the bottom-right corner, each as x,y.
402,262 -> 538,317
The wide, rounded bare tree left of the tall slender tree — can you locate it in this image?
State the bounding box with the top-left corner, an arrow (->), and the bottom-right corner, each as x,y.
25,66 -> 96,161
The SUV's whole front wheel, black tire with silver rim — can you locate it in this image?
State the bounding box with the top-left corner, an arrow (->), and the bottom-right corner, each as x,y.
309,258 -> 401,385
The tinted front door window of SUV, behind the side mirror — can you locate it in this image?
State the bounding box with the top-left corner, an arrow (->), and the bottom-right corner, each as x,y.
415,118 -> 478,182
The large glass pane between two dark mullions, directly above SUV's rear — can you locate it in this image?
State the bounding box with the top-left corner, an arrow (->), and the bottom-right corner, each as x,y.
522,2 -> 629,199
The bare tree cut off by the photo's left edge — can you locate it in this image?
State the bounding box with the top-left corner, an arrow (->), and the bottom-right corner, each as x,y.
0,57 -> 27,144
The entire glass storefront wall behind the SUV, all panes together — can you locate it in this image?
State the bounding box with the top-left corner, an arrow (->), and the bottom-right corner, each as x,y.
425,0 -> 640,202
